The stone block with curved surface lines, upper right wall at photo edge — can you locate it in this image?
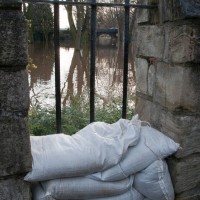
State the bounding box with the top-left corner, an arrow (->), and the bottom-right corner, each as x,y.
169,20 -> 200,63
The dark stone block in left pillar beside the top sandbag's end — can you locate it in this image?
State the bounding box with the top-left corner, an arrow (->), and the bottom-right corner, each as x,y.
0,115 -> 31,178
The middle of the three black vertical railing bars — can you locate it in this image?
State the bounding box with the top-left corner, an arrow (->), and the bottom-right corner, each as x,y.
90,0 -> 96,122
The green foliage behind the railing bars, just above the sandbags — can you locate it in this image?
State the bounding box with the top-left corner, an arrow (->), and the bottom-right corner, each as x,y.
29,95 -> 134,135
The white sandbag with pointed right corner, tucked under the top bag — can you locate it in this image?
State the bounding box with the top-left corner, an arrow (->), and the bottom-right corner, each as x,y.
89,126 -> 179,181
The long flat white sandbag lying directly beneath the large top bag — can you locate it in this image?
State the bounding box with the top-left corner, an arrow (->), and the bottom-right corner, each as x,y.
37,176 -> 133,200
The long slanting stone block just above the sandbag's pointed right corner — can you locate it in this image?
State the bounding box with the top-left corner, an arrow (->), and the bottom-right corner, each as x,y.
136,93 -> 200,158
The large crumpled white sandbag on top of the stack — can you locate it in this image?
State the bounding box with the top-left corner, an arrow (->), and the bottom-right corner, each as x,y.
25,119 -> 140,182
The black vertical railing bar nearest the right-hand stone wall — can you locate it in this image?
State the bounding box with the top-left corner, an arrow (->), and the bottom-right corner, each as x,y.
122,0 -> 130,118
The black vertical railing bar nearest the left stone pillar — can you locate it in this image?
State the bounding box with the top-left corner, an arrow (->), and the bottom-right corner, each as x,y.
54,3 -> 62,133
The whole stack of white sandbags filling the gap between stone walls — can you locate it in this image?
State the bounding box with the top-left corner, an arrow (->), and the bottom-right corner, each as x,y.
25,117 -> 179,200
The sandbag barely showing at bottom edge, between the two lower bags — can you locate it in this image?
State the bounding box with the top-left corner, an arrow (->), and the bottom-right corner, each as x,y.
90,187 -> 144,200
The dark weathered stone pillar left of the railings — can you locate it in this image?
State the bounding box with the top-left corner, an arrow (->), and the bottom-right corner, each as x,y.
0,0 -> 31,200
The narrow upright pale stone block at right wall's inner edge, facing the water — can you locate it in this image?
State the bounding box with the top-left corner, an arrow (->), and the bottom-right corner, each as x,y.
136,58 -> 148,94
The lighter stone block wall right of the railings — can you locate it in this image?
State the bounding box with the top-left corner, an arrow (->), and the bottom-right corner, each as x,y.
135,0 -> 200,200
